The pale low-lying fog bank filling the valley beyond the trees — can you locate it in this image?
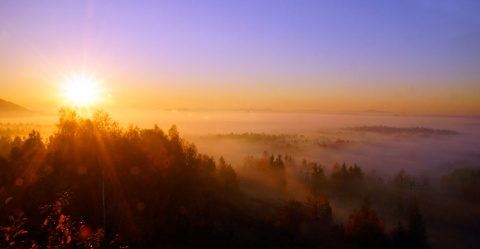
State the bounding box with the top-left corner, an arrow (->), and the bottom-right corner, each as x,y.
117,111 -> 480,177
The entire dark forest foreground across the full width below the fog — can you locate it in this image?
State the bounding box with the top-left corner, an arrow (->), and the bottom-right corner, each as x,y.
0,110 -> 480,248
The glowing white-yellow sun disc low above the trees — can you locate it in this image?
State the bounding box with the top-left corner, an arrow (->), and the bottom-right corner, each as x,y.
64,76 -> 100,107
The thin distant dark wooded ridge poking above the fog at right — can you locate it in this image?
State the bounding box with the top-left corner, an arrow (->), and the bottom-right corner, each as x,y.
348,125 -> 458,135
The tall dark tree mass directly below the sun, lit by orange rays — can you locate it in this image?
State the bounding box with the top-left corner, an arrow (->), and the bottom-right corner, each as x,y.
0,110 -> 241,248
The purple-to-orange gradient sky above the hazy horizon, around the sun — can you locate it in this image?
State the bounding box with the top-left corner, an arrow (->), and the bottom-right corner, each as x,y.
0,0 -> 480,115
